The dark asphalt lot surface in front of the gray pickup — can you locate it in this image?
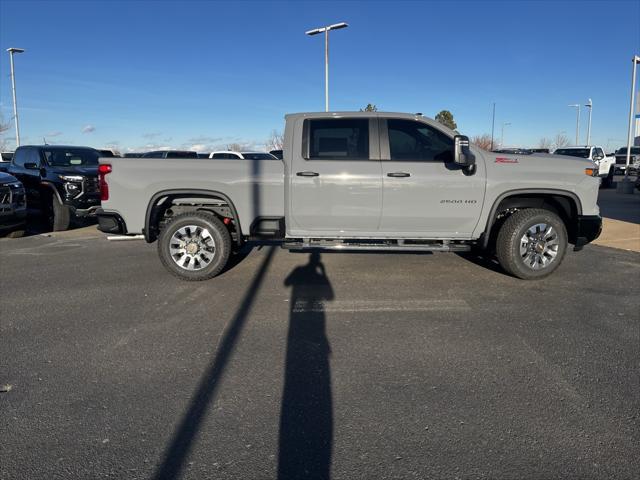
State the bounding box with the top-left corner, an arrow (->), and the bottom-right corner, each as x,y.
0,229 -> 640,480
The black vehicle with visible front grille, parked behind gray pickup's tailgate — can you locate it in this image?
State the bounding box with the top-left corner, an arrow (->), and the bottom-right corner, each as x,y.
9,145 -> 100,231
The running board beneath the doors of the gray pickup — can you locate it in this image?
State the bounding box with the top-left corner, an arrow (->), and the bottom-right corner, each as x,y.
282,239 -> 471,252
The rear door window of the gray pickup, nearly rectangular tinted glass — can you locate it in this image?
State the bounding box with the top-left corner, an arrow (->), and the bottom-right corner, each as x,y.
303,118 -> 369,160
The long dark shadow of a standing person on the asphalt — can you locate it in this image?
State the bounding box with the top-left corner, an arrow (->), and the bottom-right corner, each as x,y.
278,252 -> 334,480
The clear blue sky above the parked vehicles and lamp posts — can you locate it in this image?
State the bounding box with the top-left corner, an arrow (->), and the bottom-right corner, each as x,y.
0,0 -> 640,151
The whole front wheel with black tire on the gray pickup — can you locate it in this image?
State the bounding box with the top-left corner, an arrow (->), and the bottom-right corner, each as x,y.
496,208 -> 567,280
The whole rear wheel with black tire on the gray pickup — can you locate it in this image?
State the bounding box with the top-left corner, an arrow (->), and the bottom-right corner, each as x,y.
158,212 -> 231,281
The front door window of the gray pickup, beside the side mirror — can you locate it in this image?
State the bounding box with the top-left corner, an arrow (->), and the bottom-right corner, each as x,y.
387,119 -> 453,162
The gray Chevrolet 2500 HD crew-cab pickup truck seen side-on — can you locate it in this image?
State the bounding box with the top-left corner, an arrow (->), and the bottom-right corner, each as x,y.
97,112 -> 602,280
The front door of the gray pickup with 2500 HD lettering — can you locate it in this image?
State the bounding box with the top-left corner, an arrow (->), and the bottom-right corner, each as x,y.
380,118 -> 486,238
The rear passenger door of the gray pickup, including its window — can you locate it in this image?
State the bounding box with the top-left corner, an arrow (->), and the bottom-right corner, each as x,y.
287,117 -> 382,237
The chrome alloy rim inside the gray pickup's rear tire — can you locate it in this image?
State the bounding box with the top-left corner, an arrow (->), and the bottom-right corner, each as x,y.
169,225 -> 216,270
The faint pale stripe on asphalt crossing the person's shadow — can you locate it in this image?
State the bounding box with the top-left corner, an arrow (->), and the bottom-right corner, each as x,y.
293,300 -> 471,313
